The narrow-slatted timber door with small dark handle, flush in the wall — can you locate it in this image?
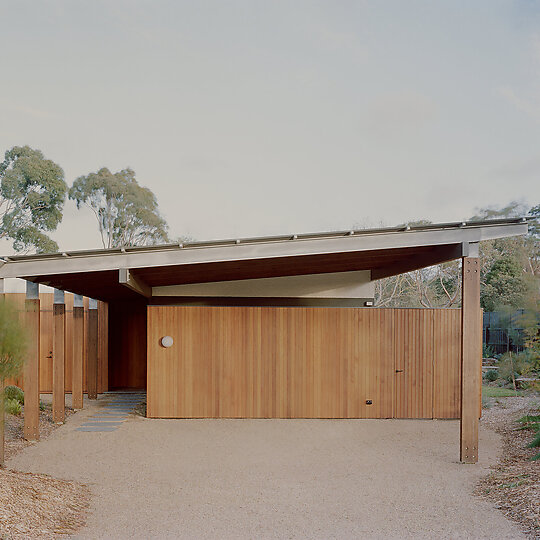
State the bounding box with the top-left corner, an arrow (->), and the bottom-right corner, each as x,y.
394,309 -> 434,418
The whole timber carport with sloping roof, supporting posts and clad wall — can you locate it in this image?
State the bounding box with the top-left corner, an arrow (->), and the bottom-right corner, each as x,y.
0,219 -> 527,463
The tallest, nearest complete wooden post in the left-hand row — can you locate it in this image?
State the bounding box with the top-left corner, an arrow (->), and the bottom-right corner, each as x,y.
24,281 -> 39,441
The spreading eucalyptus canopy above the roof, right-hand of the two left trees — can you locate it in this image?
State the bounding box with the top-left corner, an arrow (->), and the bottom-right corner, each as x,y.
69,168 -> 168,248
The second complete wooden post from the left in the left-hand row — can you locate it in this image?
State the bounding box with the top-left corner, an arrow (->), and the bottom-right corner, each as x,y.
53,289 -> 66,424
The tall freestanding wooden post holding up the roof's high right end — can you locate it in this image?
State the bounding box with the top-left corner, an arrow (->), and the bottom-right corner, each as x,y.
460,257 -> 482,463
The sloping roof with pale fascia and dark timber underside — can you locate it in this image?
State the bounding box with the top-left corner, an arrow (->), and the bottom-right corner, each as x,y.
0,218 -> 528,301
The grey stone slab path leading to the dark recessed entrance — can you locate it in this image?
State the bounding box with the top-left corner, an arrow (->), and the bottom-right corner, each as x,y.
75,392 -> 146,431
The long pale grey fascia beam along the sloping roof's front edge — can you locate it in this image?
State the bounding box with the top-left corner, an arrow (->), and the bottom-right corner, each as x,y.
0,223 -> 528,278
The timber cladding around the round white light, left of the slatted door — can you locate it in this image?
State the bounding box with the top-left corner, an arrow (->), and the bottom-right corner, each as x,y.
148,306 -> 394,418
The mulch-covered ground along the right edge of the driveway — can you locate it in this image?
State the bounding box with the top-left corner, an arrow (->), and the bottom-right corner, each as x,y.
477,396 -> 540,538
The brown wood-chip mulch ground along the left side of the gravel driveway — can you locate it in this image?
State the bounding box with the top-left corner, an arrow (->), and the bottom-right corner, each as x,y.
0,405 -> 90,540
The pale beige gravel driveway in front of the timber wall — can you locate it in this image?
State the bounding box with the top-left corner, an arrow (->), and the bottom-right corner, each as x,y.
8,396 -> 524,539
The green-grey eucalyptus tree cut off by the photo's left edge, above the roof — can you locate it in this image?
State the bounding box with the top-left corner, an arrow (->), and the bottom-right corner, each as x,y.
0,146 -> 67,253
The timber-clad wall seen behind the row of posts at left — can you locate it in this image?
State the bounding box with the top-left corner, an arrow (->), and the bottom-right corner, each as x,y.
5,293 -> 108,394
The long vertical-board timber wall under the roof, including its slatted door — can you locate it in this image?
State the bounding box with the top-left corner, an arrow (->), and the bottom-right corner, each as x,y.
148,306 -> 468,418
